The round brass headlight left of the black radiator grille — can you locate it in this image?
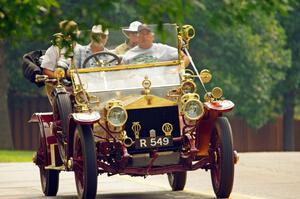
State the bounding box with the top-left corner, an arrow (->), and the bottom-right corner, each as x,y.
107,106 -> 127,127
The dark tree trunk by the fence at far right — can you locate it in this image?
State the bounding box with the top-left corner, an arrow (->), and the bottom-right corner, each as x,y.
283,91 -> 296,151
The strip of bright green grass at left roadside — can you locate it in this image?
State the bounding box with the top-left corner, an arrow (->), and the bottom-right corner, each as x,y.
0,150 -> 35,162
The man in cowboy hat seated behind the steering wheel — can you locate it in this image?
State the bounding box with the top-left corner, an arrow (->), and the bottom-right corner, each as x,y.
75,25 -> 109,68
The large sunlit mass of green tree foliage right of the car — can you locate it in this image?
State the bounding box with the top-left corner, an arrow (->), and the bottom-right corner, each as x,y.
192,2 -> 291,127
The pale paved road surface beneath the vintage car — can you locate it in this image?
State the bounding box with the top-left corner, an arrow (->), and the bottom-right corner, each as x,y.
0,152 -> 300,199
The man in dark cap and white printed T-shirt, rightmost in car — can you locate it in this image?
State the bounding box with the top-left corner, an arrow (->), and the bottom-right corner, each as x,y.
122,24 -> 189,67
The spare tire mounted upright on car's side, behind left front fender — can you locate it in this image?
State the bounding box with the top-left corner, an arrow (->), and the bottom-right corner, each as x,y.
56,93 -> 72,163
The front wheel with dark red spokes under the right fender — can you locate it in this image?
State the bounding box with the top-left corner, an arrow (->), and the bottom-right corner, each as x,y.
210,117 -> 234,198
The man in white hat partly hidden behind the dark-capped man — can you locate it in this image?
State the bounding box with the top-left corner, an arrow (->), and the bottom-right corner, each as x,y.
114,21 -> 142,55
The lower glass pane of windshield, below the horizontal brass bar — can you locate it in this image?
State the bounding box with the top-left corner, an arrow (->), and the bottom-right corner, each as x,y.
75,66 -> 180,92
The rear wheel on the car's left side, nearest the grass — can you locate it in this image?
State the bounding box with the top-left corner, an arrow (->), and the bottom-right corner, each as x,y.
39,137 -> 59,196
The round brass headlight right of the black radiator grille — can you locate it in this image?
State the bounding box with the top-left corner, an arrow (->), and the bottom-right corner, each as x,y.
183,99 -> 204,120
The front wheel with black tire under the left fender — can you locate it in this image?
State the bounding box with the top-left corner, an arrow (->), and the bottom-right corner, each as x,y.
73,125 -> 98,199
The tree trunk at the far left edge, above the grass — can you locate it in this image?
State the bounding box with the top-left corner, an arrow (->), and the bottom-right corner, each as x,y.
0,40 -> 13,149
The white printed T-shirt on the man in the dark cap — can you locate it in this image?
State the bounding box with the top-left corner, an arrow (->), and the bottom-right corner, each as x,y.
122,43 -> 178,64
